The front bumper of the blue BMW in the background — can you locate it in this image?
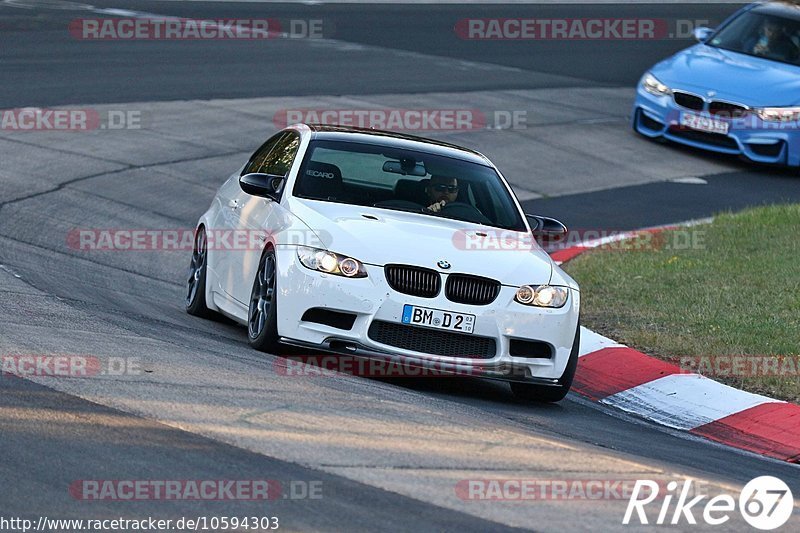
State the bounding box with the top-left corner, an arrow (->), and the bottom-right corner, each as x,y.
631,85 -> 800,166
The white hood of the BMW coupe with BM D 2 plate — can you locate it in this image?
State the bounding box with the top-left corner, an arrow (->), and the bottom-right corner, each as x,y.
288,198 -> 553,286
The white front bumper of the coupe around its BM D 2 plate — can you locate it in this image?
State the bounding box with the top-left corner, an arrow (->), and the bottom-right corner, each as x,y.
277,246 -> 580,385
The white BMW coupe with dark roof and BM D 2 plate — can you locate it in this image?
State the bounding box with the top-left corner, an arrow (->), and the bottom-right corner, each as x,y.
186,124 -> 580,402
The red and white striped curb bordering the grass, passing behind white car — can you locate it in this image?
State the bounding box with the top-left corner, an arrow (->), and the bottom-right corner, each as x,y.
552,220 -> 800,463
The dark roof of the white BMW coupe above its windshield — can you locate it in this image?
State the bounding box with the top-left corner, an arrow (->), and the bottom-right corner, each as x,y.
296,124 -> 492,166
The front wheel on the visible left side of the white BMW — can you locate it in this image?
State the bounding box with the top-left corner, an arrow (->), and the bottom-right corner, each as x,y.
247,250 -> 282,354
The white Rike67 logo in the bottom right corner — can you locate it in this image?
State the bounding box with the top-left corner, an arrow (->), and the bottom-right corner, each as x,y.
622,476 -> 794,531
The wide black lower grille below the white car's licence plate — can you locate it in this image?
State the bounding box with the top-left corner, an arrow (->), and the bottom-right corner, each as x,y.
367,320 -> 497,359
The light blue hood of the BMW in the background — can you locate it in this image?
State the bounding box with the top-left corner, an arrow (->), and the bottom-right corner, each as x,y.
650,44 -> 800,107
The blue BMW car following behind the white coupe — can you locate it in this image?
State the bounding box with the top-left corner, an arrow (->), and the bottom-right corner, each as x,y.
631,0 -> 800,167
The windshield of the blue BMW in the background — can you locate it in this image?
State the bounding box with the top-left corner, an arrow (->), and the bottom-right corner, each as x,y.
708,10 -> 800,65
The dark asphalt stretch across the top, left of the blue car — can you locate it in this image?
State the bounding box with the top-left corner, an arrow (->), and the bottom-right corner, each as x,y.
0,0 -> 752,107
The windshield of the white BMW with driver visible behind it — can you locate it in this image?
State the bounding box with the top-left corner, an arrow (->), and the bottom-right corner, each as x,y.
293,141 -> 525,231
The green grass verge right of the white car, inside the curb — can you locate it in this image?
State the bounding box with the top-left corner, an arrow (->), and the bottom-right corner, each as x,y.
565,204 -> 800,402
